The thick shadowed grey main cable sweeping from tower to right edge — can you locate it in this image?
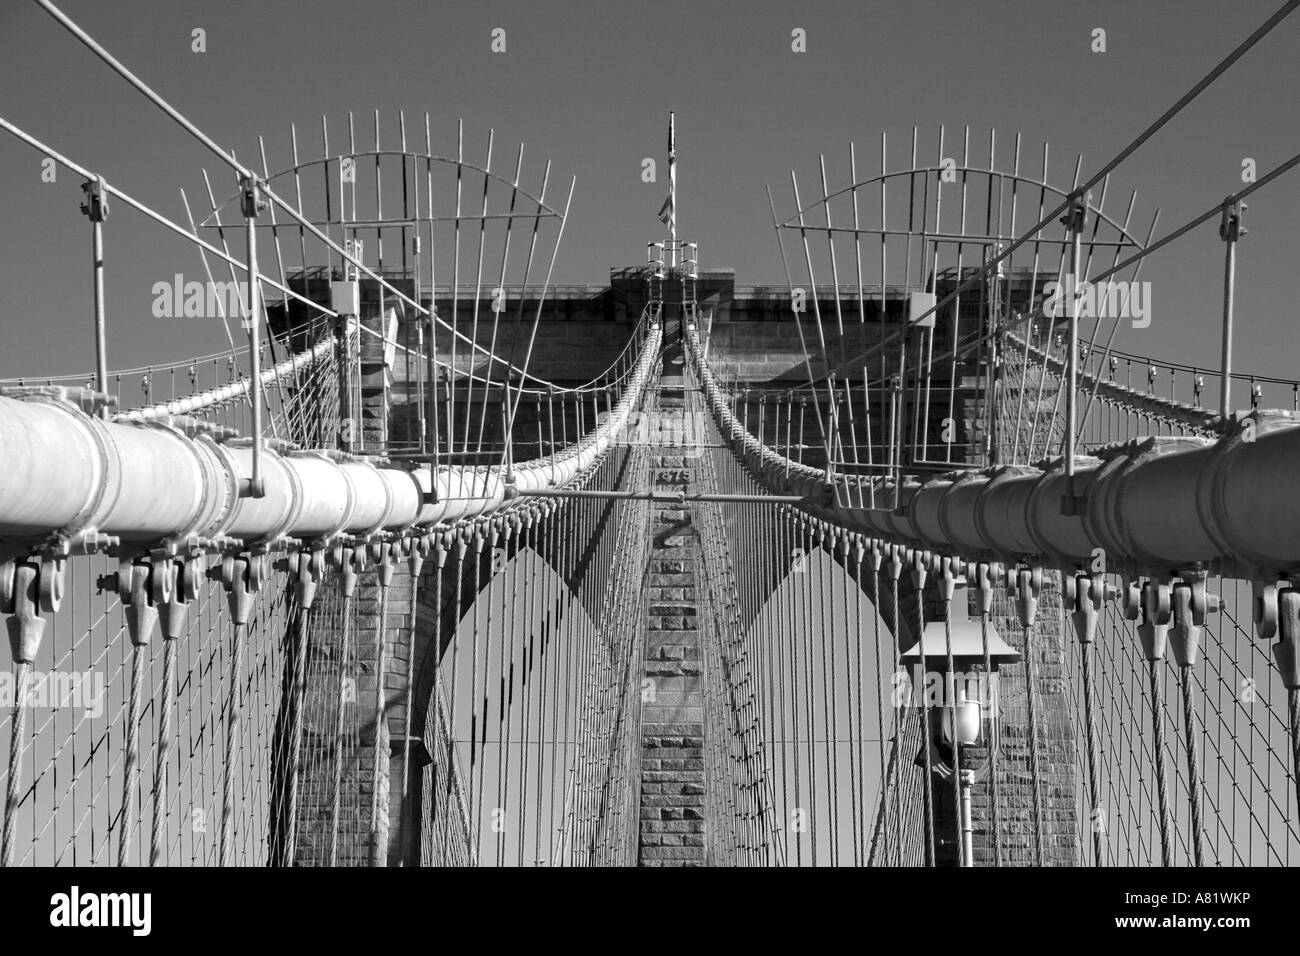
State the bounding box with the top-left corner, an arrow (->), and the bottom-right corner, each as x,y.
686,329 -> 1300,576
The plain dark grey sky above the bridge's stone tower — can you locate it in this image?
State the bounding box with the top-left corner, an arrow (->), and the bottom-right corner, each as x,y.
0,0 -> 1300,377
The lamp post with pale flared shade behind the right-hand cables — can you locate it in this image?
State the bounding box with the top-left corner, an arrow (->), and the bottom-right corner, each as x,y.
898,608 -> 1021,866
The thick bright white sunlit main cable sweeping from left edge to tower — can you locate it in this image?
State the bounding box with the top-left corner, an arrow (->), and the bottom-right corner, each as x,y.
0,328 -> 662,548
